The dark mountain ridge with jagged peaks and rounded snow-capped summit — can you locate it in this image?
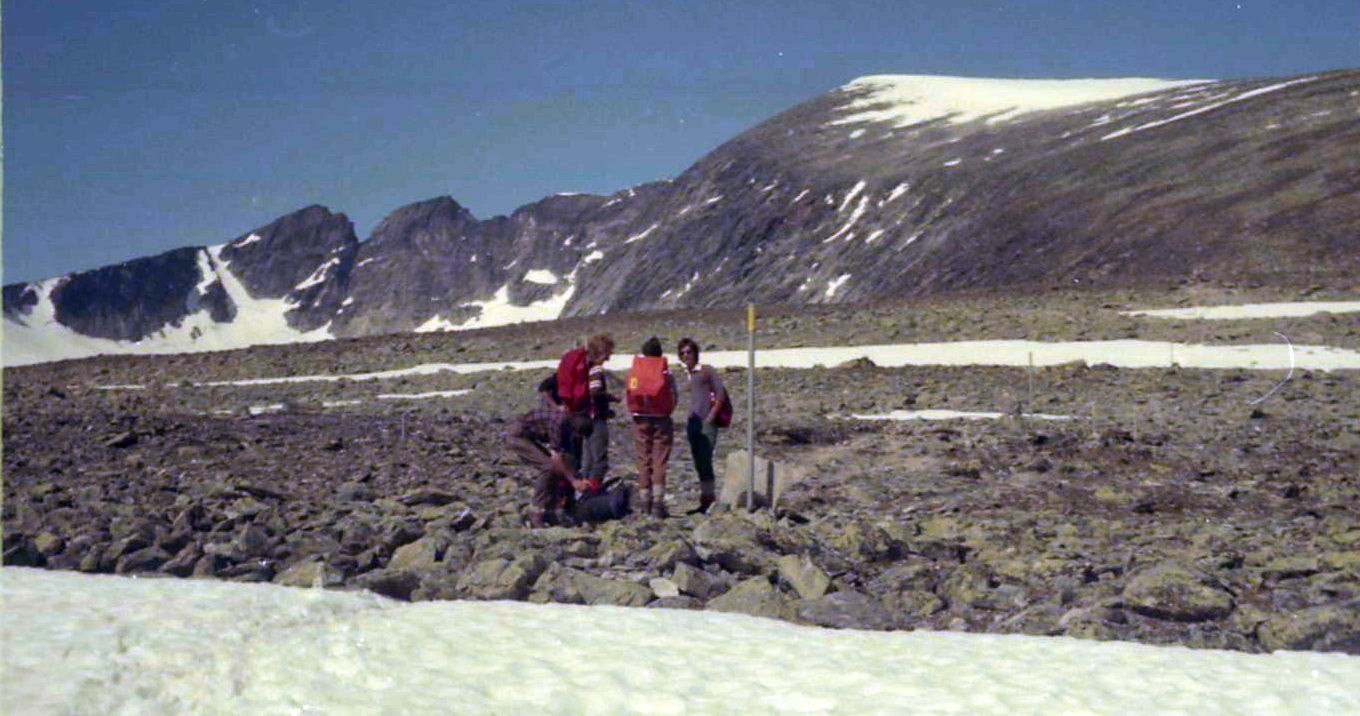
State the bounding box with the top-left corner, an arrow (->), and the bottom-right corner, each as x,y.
4,71 -> 1360,365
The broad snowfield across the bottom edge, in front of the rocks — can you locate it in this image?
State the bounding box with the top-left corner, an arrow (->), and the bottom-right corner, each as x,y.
0,568 -> 1360,715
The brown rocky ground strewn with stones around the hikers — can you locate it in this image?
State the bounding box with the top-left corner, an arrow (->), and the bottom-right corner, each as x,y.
3,289 -> 1360,653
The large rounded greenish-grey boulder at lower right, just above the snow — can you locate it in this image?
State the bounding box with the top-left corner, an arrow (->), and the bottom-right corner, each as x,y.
1123,562 -> 1234,622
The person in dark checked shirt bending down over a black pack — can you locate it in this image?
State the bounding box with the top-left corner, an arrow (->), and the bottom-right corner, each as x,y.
506,404 -> 590,527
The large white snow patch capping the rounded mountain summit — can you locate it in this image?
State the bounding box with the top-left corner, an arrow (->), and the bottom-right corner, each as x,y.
831,75 -> 1208,127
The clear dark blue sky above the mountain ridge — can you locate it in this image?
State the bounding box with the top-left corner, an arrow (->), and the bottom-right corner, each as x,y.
3,0 -> 1360,283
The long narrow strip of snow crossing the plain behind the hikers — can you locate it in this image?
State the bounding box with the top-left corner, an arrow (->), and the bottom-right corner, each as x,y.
194,340 -> 1360,388
